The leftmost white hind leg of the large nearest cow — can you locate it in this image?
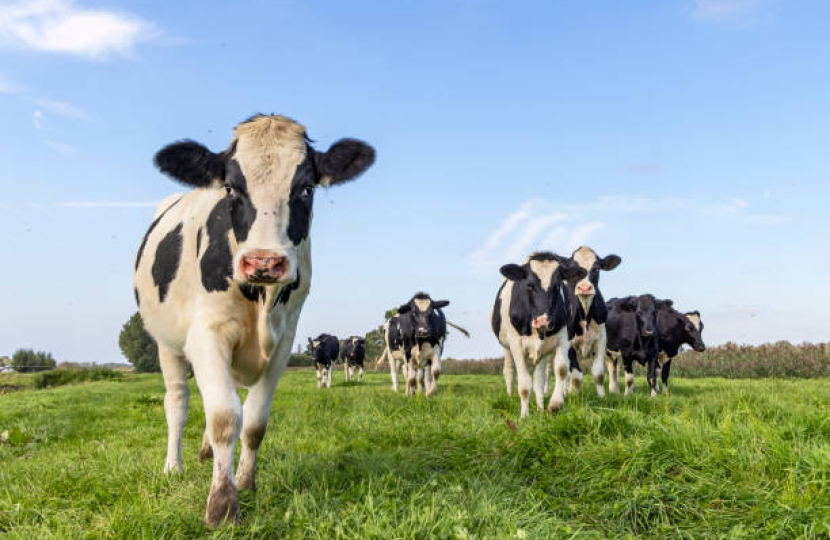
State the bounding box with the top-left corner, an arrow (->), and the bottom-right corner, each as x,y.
158,344 -> 190,473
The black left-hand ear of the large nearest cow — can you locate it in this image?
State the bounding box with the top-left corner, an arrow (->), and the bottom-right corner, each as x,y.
153,141 -> 225,187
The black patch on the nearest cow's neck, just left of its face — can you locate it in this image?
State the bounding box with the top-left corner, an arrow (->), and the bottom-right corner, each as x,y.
199,197 -> 233,292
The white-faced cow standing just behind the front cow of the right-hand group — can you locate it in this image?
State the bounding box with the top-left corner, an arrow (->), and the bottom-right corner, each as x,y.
564,246 -> 622,397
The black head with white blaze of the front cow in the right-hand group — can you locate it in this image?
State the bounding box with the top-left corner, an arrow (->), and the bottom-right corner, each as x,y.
500,252 -> 587,333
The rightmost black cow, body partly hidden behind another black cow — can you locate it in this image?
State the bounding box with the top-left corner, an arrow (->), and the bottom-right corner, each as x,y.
652,300 -> 706,395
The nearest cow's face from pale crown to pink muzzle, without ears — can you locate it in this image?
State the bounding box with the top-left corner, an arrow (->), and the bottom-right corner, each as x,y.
231,116 -> 315,283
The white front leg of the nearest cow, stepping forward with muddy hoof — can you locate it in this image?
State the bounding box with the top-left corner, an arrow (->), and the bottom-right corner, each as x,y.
186,331 -> 242,527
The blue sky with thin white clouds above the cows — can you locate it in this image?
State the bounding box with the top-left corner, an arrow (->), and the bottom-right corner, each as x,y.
0,0 -> 830,362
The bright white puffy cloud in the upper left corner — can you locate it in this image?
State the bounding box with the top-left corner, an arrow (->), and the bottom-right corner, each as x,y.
0,0 -> 154,58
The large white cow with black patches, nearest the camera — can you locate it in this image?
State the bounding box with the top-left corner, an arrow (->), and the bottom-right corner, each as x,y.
134,115 -> 375,526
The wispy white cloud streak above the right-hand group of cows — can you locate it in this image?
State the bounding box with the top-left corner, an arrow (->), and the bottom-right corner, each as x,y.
467,195 -> 786,271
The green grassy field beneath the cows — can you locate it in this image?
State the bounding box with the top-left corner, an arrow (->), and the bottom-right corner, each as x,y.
0,371 -> 830,540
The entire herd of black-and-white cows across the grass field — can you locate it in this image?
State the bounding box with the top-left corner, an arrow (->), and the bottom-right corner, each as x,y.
134,115 -> 703,526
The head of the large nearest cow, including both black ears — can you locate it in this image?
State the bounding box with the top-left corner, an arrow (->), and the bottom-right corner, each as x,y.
155,115 -> 375,289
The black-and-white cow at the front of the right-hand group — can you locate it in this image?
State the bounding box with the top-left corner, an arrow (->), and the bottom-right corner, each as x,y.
491,252 -> 588,418
